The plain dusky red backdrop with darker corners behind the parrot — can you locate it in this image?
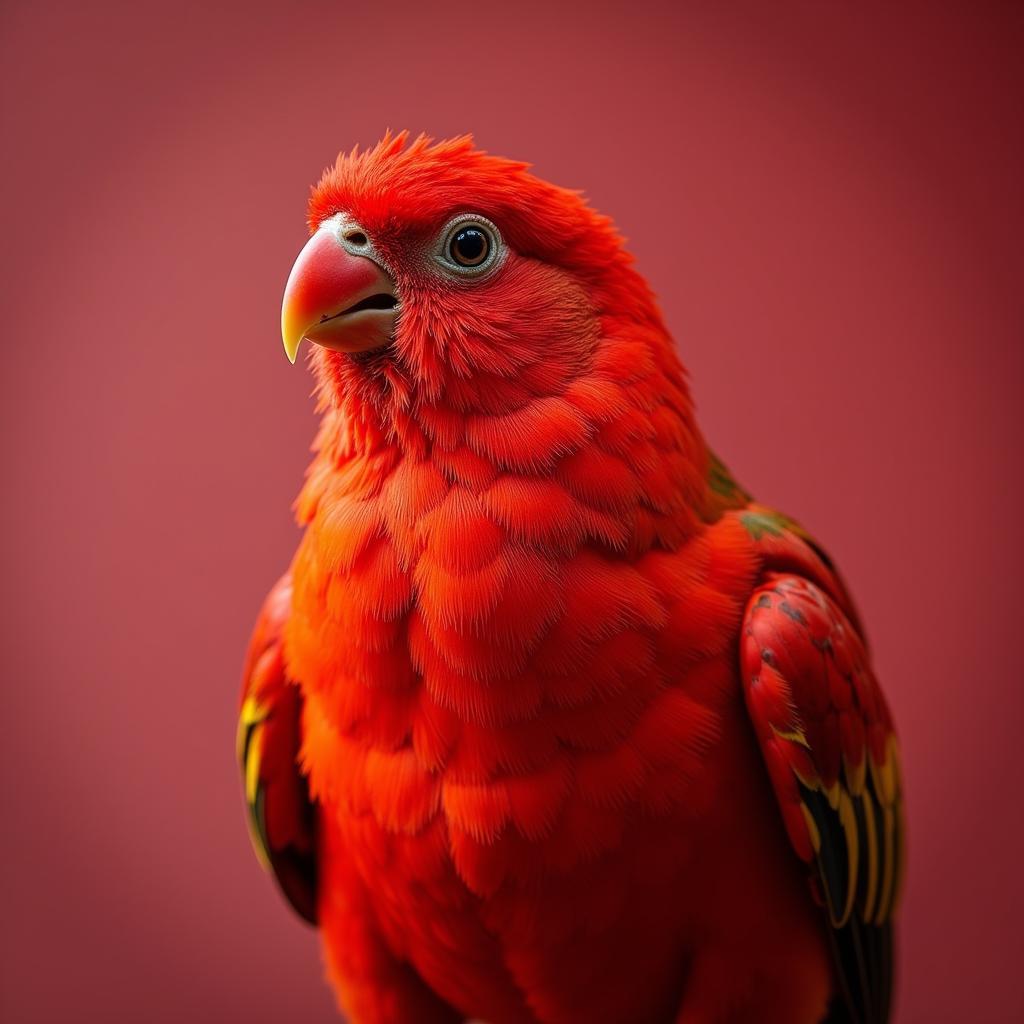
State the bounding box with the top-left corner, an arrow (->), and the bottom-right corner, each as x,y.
0,2 -> 1024,1024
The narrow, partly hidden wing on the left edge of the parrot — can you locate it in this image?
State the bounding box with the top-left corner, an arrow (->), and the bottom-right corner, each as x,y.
237,574 -> 316,925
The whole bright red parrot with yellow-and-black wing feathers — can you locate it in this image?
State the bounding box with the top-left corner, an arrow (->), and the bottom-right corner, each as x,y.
237,132 -> 904,1024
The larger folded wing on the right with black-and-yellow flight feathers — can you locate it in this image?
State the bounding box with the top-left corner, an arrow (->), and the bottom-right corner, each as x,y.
740,571 -> 903,1024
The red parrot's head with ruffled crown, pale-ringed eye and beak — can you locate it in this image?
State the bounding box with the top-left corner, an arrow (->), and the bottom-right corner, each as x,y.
282,133 -> 671,421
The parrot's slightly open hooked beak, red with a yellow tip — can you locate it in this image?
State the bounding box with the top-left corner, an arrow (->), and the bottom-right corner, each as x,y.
281,217 -> 398,362
